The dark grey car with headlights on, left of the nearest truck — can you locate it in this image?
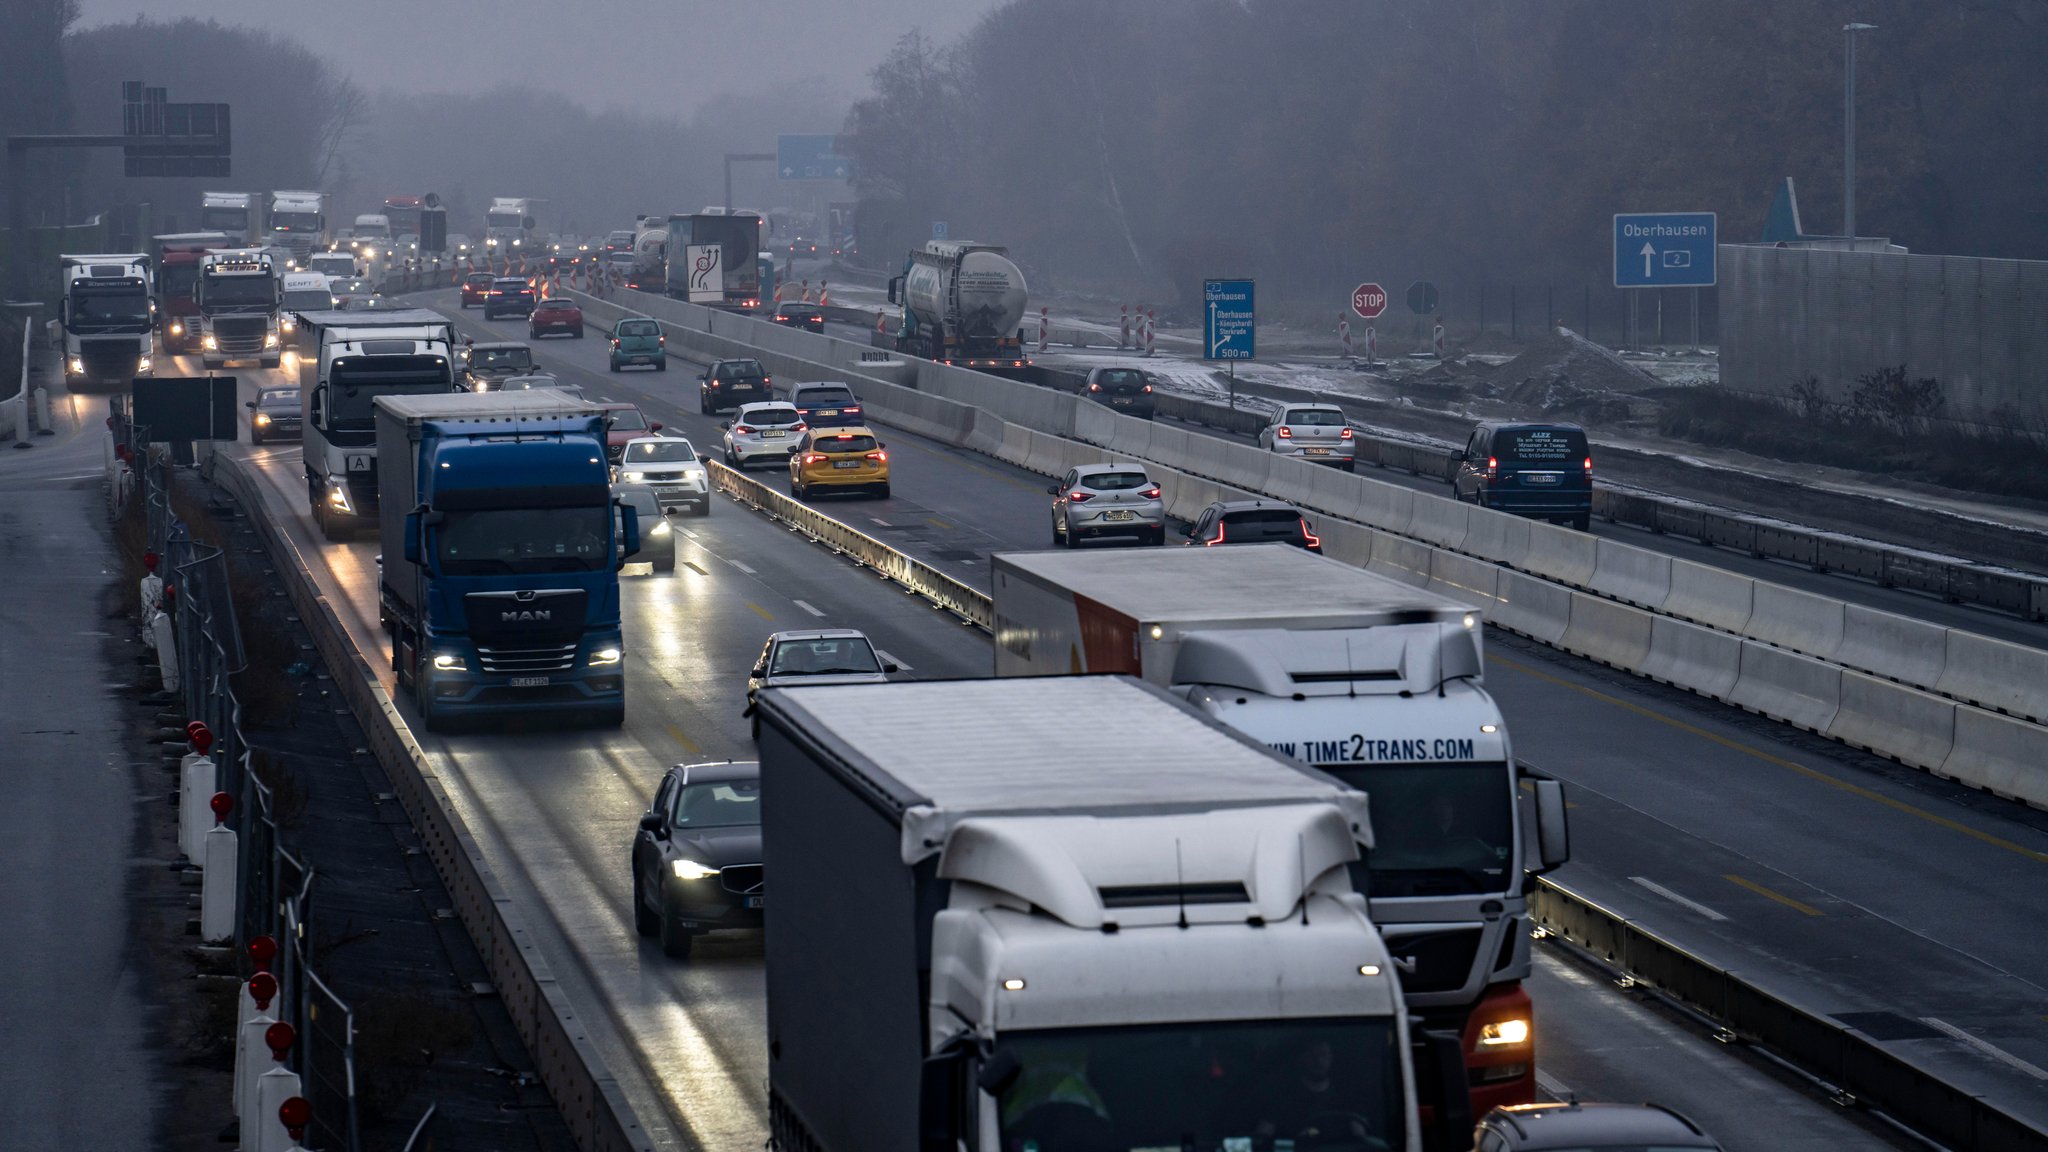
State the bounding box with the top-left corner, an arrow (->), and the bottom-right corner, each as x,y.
633,760 -> 768,959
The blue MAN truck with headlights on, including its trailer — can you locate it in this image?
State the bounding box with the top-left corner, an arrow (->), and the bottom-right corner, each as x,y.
372,389 -> 639,728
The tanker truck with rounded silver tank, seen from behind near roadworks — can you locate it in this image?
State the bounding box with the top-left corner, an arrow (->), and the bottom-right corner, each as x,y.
889,240 -> 1028,369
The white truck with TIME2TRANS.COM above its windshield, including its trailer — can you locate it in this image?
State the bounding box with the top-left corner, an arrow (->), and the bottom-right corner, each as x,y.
991,545 -> 1567,1111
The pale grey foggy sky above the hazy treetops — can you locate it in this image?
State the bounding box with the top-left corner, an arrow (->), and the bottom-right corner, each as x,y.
78,0 -> 995,115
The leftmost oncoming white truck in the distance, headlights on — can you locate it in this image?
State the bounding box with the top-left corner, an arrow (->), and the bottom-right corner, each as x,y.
57,252 -> 156,387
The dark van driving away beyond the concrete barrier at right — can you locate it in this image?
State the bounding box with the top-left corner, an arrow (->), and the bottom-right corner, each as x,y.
1450,420 -> 1593,531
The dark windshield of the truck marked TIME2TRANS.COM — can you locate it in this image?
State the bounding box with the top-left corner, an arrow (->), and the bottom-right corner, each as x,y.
1317,760 -> 1522,896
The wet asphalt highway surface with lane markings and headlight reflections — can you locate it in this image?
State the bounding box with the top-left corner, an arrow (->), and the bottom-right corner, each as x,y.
176,284 -> 2048,1148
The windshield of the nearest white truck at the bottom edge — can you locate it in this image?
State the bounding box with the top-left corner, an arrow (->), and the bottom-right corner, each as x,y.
997,1019 -> 1407,1152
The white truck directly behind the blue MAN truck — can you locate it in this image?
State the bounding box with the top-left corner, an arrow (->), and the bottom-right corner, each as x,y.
295,307 -> 457,539
